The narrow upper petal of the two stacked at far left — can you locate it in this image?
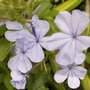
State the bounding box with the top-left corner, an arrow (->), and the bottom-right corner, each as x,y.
6,21 -> 23,31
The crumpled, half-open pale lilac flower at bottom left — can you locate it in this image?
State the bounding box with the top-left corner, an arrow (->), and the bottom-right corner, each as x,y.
11,71 -> 26,89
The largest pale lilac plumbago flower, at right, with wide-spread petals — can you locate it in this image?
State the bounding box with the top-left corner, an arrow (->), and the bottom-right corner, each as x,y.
42,10 -> 90,65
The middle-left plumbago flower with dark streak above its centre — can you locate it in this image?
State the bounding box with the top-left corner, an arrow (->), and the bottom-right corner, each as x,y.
5,16 -> 50,63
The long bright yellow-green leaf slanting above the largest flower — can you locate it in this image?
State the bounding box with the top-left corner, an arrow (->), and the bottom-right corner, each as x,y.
43,0 -> 83,19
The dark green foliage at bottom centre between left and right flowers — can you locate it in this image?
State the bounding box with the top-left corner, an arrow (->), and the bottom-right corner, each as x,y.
27,63 -> 65,90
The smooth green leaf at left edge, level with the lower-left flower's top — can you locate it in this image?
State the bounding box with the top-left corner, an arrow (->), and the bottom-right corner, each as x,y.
0,38 -> 11,61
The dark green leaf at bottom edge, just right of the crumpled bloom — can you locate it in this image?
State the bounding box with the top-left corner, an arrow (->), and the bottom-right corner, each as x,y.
27,71 -> 47,90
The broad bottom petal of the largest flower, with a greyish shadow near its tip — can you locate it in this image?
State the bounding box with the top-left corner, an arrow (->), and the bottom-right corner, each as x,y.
56,39 -> 76,65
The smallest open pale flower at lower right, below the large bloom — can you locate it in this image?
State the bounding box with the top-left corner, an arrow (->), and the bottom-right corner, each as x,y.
54,64 -> 87,89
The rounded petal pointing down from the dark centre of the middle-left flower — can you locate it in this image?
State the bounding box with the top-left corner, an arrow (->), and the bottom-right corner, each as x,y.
26,43 -> 44,63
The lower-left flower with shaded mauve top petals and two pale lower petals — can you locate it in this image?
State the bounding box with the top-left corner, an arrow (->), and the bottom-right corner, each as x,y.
8,38 -> 32,73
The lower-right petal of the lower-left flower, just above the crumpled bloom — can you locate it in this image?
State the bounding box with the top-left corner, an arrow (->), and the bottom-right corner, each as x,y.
18,55 -> 32,73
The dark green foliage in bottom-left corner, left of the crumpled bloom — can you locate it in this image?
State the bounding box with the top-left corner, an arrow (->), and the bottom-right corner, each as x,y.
0,58 -> 14,90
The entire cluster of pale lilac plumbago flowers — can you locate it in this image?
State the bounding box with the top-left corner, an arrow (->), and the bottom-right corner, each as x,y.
2,10 -> 90,89
